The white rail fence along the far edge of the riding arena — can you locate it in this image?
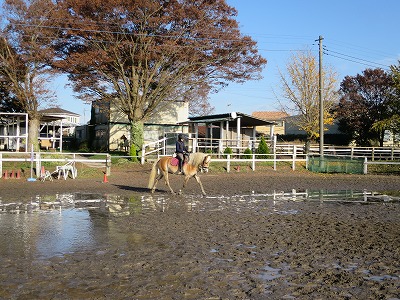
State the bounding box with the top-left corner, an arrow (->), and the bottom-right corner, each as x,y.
0,144 -> 400,178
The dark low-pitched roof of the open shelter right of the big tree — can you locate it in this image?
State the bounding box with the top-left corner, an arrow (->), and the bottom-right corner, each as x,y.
182,112 -> 275,127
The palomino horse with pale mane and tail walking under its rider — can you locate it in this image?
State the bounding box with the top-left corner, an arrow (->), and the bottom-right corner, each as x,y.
148,152 -> 211,195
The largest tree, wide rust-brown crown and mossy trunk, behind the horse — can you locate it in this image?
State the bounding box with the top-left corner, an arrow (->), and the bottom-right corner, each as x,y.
53,0 -> 266,158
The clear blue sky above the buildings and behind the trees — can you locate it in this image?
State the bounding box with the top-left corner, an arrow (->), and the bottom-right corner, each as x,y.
47,0 -> 400,121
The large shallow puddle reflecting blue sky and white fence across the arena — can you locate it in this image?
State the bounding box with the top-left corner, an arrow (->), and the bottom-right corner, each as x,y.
0,190 -> 400,258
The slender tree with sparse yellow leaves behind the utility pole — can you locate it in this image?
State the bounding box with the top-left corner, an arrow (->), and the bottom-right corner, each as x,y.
279,50 -> 338,149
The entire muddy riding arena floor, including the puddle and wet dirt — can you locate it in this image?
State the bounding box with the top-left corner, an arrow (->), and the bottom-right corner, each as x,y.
0,164 -> 400,299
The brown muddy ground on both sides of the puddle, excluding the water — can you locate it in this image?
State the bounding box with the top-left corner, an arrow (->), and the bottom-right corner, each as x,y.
0,165 -> 400,299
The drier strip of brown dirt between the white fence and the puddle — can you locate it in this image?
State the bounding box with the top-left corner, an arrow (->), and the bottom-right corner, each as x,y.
0,163 -> 400,201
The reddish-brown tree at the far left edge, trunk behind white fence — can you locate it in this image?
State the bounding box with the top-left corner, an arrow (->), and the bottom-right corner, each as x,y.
0,0 -> 54,150
